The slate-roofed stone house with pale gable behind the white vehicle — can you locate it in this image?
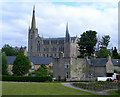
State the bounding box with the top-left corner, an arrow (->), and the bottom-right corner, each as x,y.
87,56 -> 120,77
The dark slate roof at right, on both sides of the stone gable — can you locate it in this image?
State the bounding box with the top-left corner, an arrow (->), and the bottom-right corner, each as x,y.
88,58 -> 120,66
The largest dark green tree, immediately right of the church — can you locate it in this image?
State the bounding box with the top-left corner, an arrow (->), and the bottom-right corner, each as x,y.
78,30 -> 97,56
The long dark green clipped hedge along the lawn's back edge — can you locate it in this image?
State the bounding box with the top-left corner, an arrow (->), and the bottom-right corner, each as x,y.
2,75 -> 52,82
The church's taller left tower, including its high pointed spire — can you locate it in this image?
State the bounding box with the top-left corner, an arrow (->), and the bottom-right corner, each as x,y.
28,6 -> 39,56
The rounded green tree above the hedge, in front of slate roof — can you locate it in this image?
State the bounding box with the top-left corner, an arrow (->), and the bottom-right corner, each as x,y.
12,53 -> 31,76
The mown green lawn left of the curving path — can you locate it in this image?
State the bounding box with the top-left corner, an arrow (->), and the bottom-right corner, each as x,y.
2,82 -> 94,95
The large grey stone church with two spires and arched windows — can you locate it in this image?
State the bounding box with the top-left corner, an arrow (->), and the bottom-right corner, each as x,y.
28,7 -> 79,58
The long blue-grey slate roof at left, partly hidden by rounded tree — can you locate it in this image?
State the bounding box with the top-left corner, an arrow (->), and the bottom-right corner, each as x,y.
6,56 -> 52,65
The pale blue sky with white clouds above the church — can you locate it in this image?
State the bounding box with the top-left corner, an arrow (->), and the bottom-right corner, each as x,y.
0,0 -> 118,48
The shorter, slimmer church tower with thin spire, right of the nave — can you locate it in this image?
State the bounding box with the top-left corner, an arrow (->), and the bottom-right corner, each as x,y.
64,23 -> 71,57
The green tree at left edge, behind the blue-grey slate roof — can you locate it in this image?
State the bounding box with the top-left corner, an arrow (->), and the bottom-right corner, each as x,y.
2,44 -> 15,56
